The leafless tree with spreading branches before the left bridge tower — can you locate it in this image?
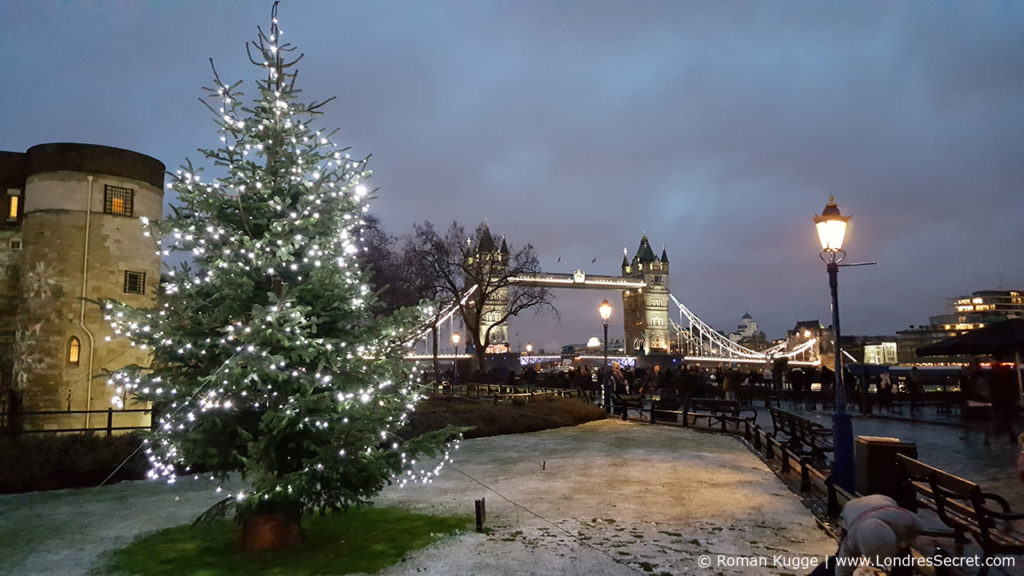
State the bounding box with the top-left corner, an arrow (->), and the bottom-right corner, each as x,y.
404,221 -> 558,371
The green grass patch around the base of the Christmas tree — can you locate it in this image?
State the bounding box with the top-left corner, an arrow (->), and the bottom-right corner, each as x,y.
92,506 -> 473,576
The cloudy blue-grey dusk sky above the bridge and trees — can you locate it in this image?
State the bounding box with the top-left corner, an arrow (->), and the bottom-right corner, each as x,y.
0,1 -> 1024,345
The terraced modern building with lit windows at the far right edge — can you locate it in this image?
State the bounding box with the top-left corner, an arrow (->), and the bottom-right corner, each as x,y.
896,290 -> 1024,363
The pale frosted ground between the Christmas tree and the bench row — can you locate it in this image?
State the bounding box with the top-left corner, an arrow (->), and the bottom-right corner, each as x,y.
372,419 -> 837,576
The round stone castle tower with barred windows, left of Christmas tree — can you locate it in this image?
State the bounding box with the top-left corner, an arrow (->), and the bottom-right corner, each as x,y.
0,143 -> 164,428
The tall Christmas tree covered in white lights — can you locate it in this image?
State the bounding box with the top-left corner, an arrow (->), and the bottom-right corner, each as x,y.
103,4 -> 458,548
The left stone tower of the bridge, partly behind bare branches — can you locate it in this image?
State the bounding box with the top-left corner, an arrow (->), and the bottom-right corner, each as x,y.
466,228 -> 509,352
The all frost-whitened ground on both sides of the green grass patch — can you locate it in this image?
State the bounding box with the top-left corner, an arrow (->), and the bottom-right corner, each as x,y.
0,420 -> 836,576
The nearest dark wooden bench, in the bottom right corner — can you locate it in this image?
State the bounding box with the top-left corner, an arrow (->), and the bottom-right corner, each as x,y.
896,454 -> 1024,575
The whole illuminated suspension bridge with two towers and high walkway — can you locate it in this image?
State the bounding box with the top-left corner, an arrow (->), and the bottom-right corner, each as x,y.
410,231 -> 820,365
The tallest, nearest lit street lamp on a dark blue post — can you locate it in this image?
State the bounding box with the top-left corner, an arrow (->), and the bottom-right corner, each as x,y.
814,197 -> 853,493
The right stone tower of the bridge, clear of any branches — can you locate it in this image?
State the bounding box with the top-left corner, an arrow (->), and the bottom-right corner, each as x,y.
623,234 -> 672,355
